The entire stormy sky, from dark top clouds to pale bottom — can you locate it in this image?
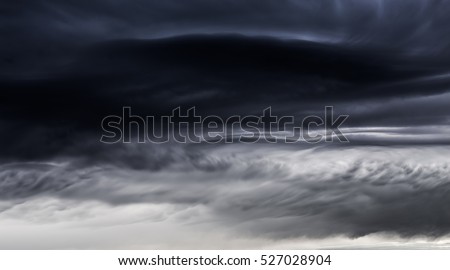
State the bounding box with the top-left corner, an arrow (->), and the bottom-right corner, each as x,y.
0,0 -> 450,249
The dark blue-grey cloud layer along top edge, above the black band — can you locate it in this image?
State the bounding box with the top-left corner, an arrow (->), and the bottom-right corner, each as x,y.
1,0 -> 449,49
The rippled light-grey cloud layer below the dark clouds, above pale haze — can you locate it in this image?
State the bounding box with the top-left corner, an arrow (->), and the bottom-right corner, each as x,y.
0,145 -> 450,243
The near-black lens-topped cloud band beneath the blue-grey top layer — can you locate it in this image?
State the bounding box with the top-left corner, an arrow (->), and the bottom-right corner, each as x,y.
0,35 -> 450,162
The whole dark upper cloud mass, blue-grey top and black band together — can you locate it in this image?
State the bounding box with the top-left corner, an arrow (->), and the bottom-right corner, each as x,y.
0,1 -> 450,148
